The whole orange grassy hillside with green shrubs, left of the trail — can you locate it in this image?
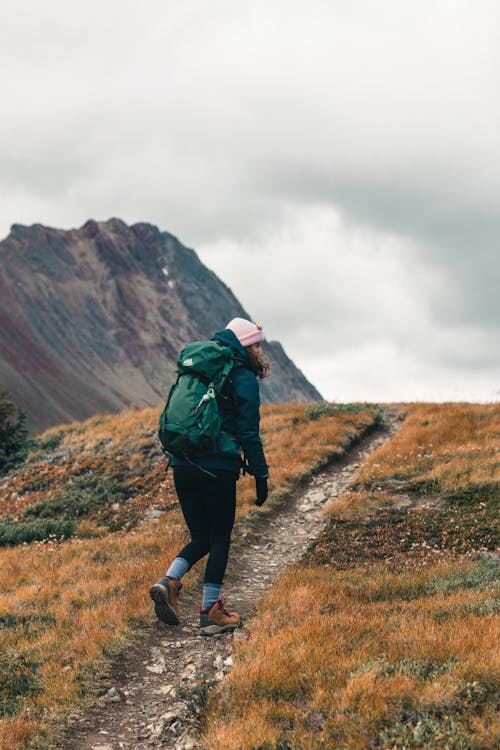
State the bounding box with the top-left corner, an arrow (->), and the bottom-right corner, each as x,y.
0,404 -> 380,750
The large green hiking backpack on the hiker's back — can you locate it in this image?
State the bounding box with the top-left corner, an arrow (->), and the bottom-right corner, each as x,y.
158,341 -> 240,460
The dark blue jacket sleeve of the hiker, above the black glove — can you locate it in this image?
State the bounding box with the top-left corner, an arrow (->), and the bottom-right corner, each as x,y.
232,367 -> 269,478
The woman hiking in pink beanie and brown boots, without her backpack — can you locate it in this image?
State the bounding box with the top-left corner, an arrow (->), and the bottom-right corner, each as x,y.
150,318 -> 269,635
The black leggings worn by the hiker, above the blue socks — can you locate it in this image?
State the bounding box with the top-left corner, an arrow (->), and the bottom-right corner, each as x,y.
174,466 -> 238,584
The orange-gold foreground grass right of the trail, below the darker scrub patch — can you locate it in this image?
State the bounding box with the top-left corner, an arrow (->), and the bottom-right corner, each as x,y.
204,563 -> 500,750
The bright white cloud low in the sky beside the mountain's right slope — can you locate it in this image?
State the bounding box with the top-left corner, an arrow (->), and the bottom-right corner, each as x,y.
199,207 -> 500,401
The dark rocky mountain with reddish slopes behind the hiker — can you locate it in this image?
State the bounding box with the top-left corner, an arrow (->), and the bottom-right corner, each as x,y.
0,219 -> 321,429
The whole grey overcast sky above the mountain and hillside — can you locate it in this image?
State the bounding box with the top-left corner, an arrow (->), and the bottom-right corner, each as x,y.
0,0 -> 500,401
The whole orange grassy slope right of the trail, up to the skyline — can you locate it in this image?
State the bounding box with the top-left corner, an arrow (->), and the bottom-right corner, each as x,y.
205,404 -> 500,750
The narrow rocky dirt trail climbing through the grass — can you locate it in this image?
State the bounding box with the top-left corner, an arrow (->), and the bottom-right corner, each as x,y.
62,417 -> 396,750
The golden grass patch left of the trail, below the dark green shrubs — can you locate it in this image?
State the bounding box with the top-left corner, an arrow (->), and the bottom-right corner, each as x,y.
0,514 -> 186,750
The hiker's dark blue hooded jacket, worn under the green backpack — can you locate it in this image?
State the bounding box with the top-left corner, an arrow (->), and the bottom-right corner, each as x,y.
172,328 -> 269,477
